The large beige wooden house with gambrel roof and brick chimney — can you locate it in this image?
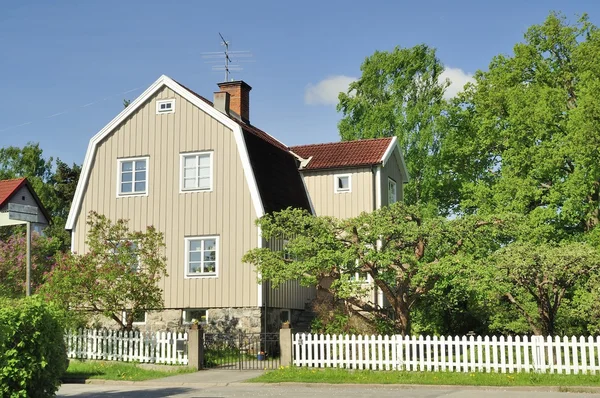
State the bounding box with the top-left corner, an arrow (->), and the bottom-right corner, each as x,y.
66,76 -> 405,332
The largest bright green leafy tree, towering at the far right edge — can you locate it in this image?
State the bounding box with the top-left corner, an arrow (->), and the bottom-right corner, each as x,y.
448,13 -> 600,241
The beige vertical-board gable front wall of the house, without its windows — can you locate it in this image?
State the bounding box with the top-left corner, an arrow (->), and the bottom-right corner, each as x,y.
73,87 -> 258,309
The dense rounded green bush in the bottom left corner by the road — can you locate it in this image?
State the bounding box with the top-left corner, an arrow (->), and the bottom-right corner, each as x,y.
0,296 -> 68,398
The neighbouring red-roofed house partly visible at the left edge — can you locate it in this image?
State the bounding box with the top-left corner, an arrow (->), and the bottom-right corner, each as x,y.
0,178 -> 51,230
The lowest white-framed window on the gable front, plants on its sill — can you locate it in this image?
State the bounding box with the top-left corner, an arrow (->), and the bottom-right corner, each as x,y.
185,236 -> 219,277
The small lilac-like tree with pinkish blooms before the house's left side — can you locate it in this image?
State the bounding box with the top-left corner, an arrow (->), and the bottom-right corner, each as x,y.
41,212 -> 167,330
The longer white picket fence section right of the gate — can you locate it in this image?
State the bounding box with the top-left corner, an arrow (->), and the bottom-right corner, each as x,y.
293,333 -> 600,374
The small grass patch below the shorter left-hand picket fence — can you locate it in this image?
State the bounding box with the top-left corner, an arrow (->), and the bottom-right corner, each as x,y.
63,359 -> 194,381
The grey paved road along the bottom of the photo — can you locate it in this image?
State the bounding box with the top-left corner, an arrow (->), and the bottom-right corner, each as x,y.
58,381 -> 600,398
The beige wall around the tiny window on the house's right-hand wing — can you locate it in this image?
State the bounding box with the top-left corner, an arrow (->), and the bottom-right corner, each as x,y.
302,167 -> 374,219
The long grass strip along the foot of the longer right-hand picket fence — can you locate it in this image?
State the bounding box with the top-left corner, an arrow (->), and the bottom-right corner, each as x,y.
250,367 -> 600,387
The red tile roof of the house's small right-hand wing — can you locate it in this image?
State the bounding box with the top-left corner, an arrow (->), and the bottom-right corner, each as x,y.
290,137 -> 392,170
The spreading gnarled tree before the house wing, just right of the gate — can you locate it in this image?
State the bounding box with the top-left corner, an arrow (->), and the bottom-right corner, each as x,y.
244,203 -> 491,333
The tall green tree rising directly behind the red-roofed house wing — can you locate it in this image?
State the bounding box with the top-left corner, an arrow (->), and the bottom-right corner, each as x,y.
337,44 -> 452,212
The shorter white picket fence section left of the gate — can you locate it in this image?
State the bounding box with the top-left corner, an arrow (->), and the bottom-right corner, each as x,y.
65,329 -> 188,365
